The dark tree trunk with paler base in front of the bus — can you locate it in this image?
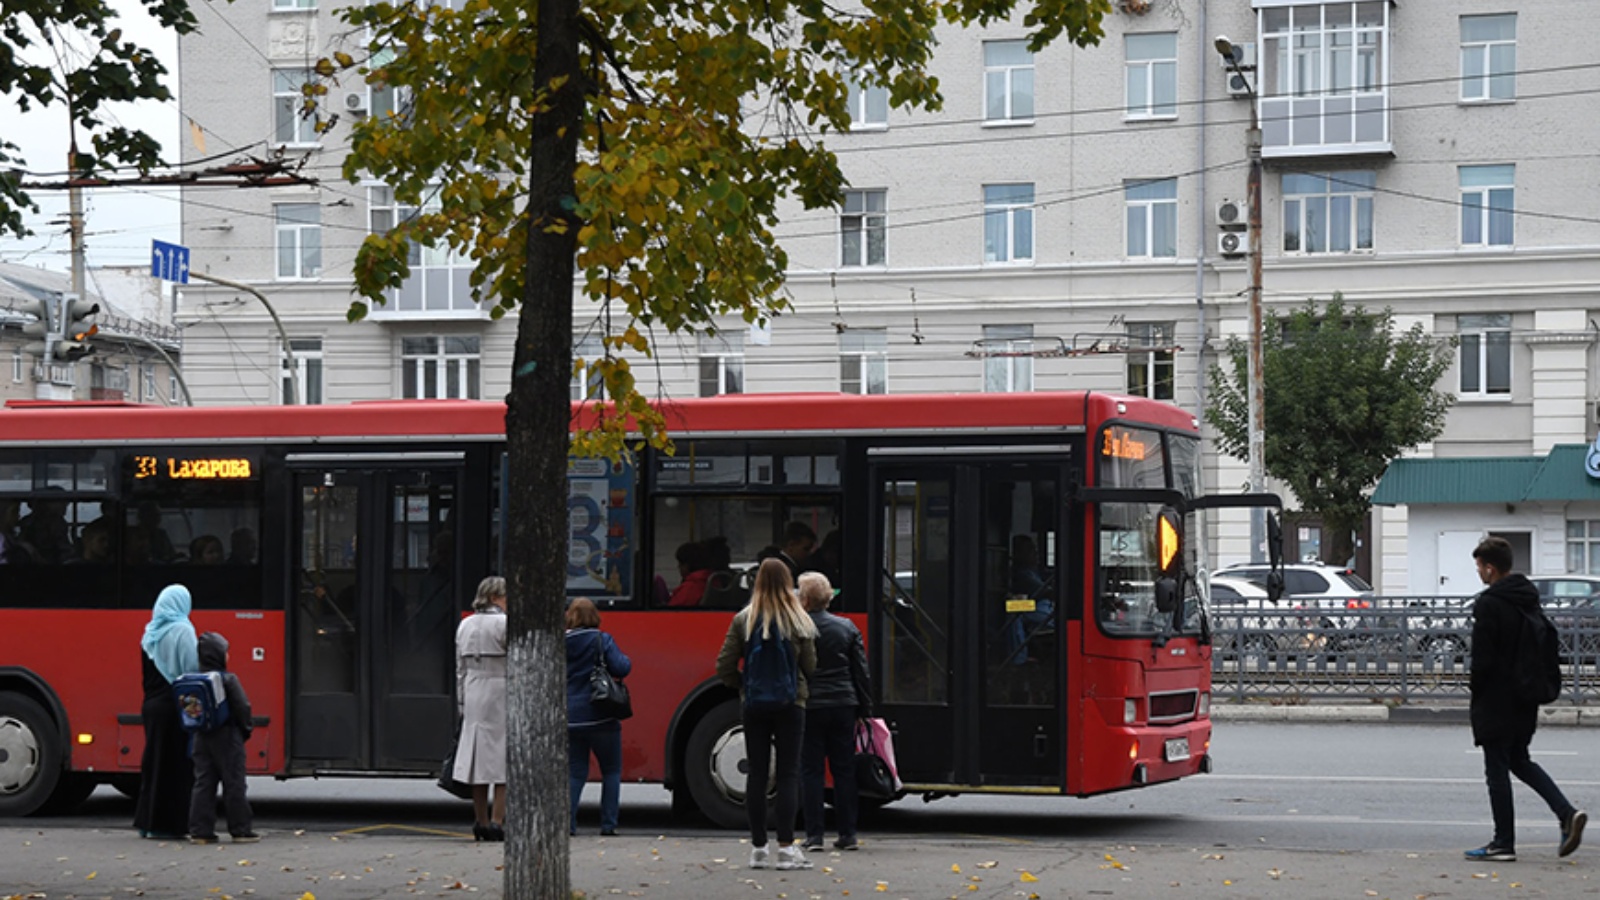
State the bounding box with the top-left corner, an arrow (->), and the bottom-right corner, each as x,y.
506,0 -> 584,900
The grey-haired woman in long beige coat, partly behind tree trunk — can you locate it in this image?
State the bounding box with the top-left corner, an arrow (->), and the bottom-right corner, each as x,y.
454,577 -> 506,841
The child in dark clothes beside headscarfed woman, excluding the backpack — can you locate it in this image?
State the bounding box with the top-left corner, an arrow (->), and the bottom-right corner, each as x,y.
189,631 -> 261,844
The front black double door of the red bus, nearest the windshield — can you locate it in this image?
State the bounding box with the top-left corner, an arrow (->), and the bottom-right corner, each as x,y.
869,447 -> 1067,788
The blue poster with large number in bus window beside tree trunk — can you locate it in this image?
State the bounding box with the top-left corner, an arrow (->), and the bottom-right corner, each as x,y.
566,460 -> 634,599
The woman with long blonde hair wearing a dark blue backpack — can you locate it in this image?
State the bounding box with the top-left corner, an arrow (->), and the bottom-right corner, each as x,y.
717,557 -> 816,870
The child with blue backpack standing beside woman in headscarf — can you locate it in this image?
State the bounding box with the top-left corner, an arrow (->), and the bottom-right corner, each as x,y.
183,631 -> 261,844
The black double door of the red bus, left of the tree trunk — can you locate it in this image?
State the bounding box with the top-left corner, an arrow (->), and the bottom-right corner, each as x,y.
288,453 -> 464,772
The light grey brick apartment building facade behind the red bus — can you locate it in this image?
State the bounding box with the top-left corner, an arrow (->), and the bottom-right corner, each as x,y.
179,0 -> 1600,593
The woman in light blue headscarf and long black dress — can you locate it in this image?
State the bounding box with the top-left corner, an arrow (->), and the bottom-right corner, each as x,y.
133,585 -> 200,841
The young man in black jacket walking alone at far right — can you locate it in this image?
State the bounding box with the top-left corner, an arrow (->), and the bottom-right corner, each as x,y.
1466,538 -> 1589,863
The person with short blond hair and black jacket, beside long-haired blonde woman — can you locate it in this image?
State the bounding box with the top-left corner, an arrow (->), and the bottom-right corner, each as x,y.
800,572 -> 872,850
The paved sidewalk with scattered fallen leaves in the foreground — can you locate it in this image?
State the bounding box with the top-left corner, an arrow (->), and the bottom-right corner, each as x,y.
0,828 -> 1594,900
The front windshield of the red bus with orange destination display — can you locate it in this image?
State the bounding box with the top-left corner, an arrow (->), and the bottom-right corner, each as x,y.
1094,426 -> 1200,637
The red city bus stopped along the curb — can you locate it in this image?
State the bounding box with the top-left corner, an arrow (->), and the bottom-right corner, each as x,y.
0,392 -> 1259,826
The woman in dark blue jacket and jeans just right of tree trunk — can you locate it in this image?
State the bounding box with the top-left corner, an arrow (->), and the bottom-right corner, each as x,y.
566,597 -> 634,834
